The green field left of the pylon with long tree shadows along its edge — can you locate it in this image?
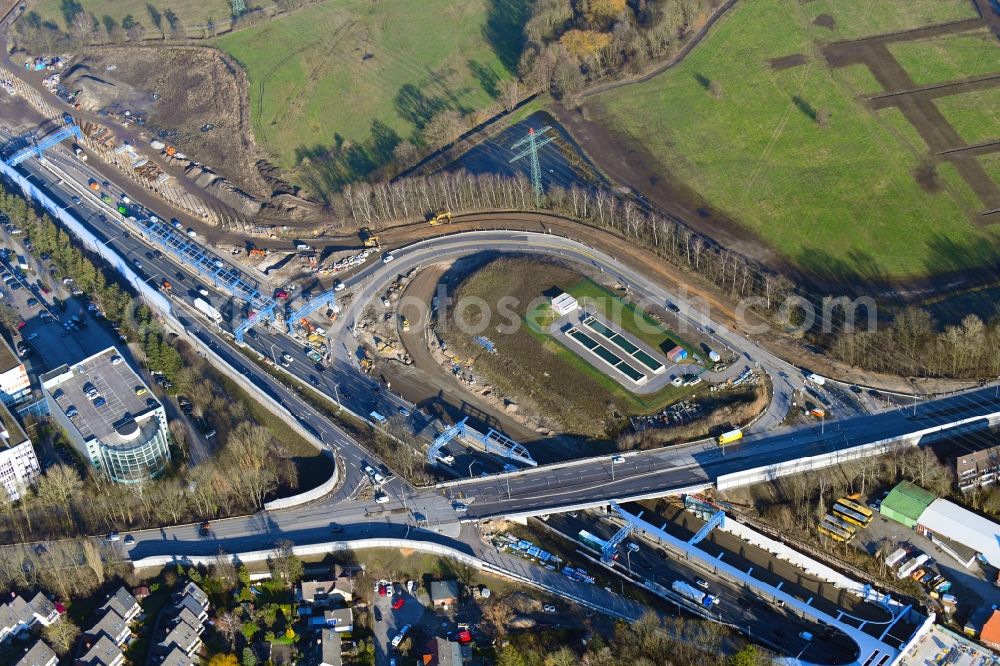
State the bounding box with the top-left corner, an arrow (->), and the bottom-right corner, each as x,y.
214,0 -> 522,171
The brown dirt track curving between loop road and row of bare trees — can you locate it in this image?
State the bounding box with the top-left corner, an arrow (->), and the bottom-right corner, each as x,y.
362,212 -> 976,395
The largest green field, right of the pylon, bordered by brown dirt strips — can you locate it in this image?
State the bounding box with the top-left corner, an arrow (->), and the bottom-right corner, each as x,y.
593,0 -> 998,279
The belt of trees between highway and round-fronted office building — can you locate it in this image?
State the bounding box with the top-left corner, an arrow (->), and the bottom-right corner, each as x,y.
0,184 -> 298,542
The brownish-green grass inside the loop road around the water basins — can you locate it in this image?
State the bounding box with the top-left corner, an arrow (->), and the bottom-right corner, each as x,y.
442,258 -> 692,439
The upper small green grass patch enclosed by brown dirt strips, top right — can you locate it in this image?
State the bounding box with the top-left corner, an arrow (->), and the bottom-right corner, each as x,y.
889,28 -> 1000,85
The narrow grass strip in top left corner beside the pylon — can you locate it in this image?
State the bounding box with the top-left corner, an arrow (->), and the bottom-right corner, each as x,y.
29,0 -> 229,31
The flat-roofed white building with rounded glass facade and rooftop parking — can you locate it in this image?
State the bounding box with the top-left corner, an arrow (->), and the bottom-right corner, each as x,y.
41,347 -> 170,483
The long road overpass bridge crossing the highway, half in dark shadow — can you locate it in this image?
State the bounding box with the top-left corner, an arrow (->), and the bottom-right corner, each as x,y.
448,387 -> 1000,520
